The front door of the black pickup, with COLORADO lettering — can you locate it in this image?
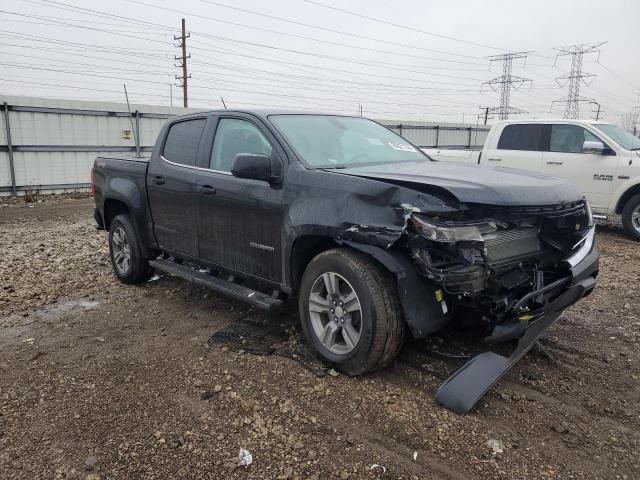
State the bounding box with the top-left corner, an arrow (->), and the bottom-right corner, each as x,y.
196,115 -> 284,282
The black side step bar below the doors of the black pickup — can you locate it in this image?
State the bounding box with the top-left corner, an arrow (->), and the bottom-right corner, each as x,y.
149,259 -> 282,310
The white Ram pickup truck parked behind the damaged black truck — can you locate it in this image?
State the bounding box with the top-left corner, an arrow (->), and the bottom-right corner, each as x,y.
423,120 -> 640,240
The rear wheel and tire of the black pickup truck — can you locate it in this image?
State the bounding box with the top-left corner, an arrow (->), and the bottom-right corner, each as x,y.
109,215 -> 152,284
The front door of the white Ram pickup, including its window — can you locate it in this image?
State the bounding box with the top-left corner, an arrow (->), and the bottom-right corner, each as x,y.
542,123 -> 618,214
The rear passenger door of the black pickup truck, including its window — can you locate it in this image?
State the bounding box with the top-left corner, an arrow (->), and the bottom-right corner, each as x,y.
146,118 -> 207,257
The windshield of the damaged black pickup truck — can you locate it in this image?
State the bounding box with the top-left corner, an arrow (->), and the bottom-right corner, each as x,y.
269,115 -> 429,168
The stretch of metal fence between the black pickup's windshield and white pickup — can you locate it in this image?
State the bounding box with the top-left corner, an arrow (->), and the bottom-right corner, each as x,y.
385,123 -> 490,149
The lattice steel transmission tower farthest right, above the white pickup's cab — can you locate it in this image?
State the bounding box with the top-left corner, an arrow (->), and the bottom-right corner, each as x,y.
551,42 -> 606,118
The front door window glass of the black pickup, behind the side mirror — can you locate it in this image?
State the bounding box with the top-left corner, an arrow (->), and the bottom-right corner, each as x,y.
209,118 -> 272,172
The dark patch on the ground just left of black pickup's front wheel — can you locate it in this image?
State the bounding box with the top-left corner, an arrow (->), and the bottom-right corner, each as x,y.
208,313 -> 327,377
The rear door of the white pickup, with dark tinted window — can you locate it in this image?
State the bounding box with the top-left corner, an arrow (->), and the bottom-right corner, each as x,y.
481,123 -> 544,172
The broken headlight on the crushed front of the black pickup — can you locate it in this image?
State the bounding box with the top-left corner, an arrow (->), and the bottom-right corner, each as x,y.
411,214 -> 498,243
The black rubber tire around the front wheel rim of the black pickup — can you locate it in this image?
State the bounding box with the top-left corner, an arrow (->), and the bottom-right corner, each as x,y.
298,248 -> 405,375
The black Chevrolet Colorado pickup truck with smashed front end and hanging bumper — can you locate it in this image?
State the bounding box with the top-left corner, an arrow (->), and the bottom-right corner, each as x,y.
92,110 -> 598,411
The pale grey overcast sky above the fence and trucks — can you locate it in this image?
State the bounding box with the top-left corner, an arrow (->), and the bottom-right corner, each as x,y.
0,0 -> 640,123
